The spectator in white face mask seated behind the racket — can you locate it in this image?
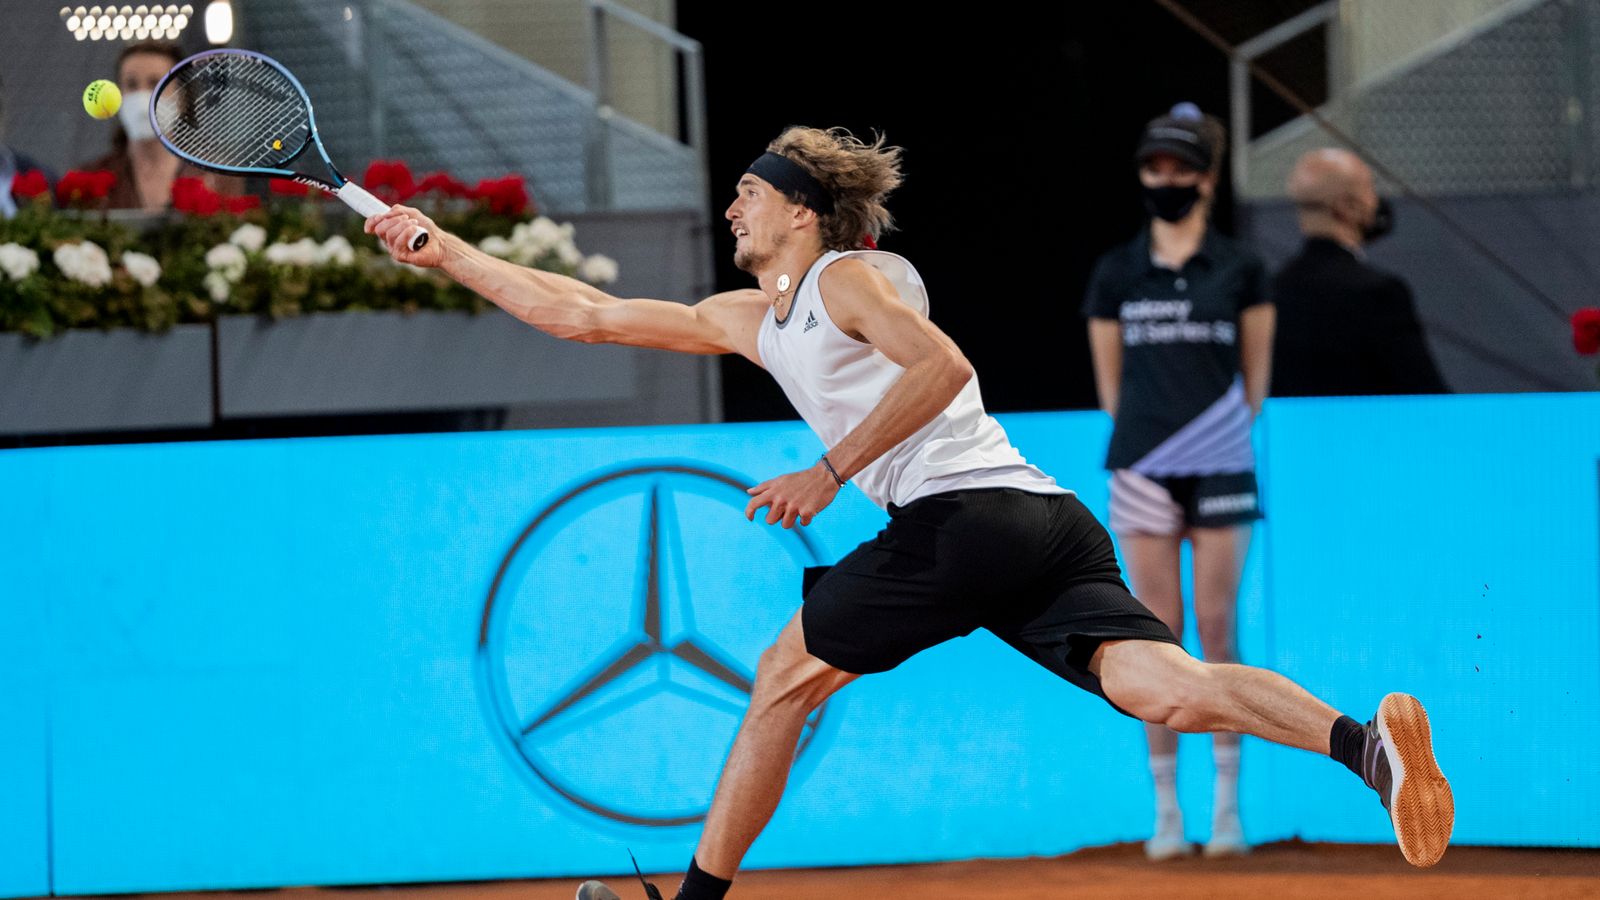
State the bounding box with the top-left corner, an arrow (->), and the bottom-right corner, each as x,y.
78,42 -> 240,211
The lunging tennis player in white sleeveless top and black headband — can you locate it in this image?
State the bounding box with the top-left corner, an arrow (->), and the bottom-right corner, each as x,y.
366,128 -> 1454,900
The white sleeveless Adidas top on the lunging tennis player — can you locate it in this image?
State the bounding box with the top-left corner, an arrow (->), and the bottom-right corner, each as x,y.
757,250 -> 1072,508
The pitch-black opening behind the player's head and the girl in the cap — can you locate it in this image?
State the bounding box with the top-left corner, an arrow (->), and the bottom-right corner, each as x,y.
678,0 -> 1326,421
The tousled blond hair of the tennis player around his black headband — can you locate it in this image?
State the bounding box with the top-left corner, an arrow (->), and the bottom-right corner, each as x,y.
766,125 -> 904,250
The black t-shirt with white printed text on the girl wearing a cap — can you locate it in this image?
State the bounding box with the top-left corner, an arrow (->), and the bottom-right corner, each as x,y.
1083,227 -> 1267,476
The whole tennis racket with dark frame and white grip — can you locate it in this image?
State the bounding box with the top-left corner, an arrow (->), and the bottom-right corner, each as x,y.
150,50 -> 427,251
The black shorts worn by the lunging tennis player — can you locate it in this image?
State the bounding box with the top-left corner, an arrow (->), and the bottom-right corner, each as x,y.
800,488 -> 1178,711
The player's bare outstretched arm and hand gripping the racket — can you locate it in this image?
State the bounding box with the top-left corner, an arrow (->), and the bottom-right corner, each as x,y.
366,207 -> 766,357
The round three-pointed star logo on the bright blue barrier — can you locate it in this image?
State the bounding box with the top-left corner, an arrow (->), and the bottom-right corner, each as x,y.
478,463 -> 822,826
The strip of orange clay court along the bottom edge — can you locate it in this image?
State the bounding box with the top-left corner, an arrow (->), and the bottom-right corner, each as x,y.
59,842 -> 1600,900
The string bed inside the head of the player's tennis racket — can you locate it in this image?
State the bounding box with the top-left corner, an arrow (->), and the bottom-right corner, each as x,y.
155,54 -> 310,168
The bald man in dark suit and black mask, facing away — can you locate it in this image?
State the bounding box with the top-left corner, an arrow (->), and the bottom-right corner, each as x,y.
1269,149 -> 1450,397
